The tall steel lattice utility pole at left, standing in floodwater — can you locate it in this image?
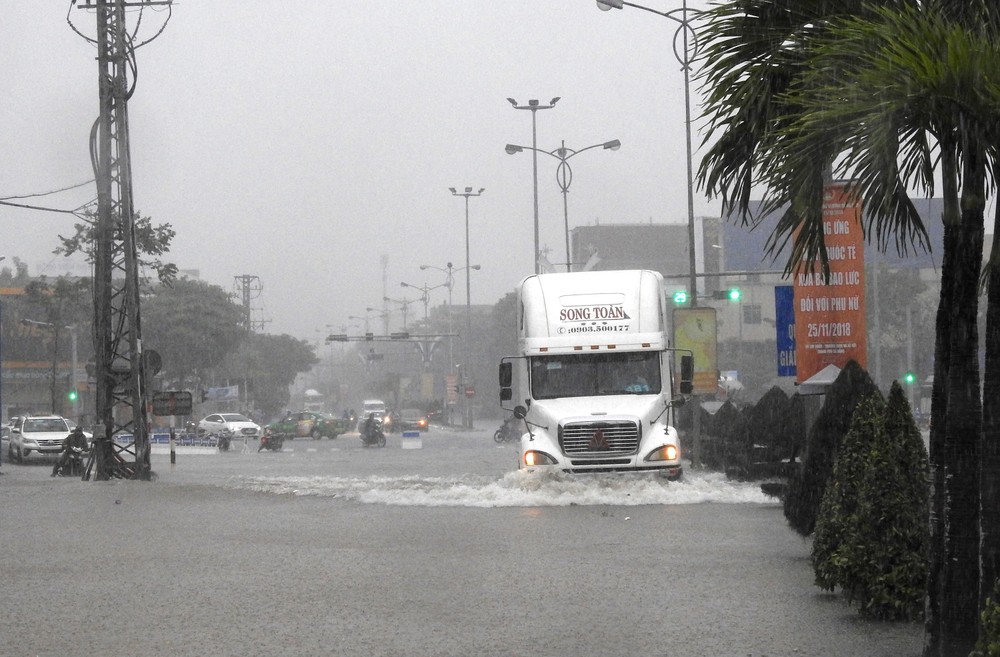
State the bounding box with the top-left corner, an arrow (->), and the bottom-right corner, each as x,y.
77,0 -> 171,480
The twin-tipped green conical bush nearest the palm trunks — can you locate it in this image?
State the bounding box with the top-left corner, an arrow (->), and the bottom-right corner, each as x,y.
812,382 -> 929,620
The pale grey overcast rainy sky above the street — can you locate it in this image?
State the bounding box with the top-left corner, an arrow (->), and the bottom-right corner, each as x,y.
0,0 -> 719,341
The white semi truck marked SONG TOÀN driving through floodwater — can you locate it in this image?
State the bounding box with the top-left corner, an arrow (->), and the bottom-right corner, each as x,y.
500,270 -> 693,479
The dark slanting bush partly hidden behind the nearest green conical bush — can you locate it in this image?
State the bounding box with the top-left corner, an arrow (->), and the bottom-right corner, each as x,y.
784,360 -> 879,536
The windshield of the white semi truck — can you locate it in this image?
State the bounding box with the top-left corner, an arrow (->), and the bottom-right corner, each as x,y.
531,351 -> 660,399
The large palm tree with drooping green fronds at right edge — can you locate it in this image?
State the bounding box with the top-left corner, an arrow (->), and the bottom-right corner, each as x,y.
699,0 -> 1000,655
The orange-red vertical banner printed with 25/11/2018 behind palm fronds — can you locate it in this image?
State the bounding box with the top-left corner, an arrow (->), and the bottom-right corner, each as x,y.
794,183 -> 868,383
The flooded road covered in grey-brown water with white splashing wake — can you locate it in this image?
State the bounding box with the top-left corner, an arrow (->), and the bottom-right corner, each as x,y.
0,429 -> 921,657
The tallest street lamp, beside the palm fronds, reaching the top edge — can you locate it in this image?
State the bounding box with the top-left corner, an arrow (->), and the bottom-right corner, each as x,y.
597,0 -> 701,306
